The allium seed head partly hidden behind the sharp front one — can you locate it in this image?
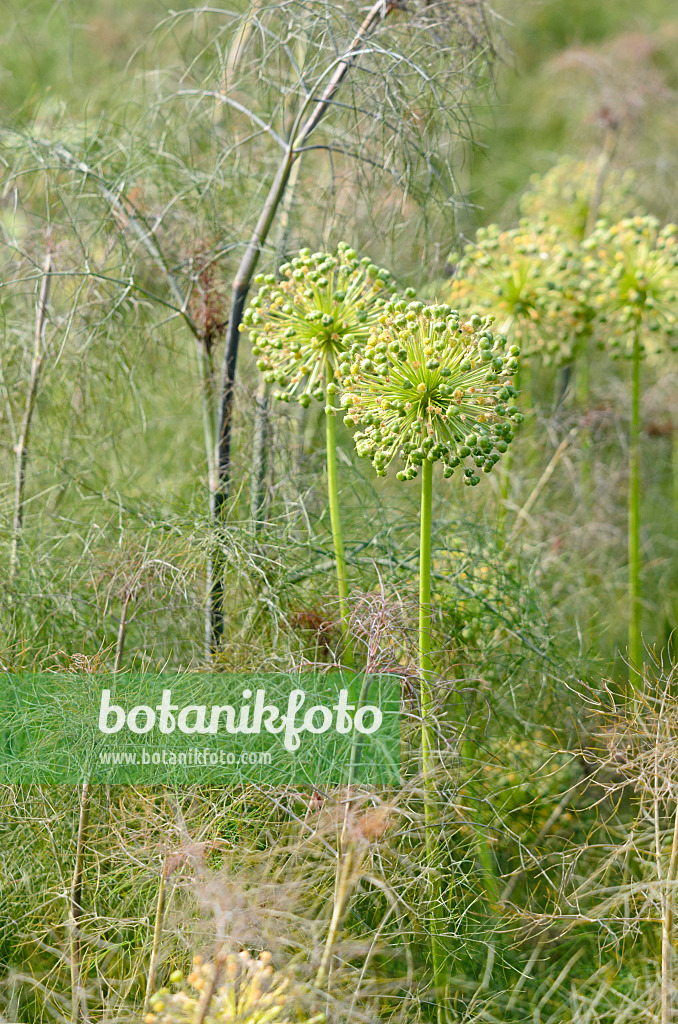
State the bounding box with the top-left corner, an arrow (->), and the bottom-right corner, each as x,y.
243,242 -> 405,407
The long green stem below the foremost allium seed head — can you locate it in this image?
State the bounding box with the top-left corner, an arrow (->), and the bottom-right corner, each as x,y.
419,459 -> 446,1022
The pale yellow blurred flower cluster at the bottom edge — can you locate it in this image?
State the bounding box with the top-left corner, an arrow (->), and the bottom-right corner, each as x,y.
144,951 -> 289,1024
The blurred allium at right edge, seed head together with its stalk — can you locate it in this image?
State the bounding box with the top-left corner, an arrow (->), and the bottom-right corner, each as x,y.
584,217 -> 678,686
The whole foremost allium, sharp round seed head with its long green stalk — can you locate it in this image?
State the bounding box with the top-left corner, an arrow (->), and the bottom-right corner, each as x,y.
338,300 -> 522,1003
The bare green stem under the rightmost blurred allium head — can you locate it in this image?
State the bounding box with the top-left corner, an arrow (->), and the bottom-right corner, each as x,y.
629,328 -> 642,687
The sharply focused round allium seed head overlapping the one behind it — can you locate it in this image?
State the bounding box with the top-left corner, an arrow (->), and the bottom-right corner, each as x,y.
338,300 -> 522,485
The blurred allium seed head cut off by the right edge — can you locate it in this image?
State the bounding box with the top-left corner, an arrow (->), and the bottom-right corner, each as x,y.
583,216 -> 678,354
